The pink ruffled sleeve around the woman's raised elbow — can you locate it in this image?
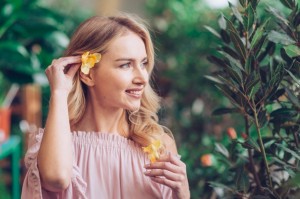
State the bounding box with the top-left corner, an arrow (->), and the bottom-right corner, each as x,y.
21,129 -> 87,199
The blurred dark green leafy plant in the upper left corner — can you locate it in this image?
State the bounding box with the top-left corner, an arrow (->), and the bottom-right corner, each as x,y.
0,0 -> 74,84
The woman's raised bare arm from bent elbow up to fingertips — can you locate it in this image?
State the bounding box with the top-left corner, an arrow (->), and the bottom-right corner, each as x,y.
37,57 -> 80,192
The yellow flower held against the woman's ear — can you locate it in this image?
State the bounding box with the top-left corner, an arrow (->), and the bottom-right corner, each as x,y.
81,51 -> 101,75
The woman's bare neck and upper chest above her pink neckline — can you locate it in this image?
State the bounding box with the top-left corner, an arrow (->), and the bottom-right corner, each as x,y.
72,93 -> 129,137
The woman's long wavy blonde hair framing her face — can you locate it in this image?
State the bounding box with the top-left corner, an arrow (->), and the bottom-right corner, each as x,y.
65,14 -> 170,146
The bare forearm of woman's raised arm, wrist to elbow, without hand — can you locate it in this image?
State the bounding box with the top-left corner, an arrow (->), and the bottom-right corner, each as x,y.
38,92 -> 73,191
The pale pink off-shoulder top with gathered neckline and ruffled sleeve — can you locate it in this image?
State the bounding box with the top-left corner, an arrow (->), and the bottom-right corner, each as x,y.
22,129 -> 172,199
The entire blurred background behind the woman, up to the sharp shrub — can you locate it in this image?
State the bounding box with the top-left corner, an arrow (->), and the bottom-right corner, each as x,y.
0,0 -> 292,199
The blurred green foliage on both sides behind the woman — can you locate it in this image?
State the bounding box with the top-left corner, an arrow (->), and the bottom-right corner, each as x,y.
0,0 -> 298,198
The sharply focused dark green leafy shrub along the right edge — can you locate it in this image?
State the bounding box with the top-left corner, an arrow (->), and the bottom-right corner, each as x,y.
207,0 -> 300,198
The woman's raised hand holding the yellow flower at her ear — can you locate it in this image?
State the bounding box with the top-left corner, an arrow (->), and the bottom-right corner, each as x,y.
45,56 -> 81,94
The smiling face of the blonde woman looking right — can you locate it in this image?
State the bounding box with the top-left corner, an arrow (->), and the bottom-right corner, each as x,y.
92,32 -> 149,111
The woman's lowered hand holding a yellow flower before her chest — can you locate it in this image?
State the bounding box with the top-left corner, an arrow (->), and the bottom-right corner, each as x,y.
145,153 -> 190,199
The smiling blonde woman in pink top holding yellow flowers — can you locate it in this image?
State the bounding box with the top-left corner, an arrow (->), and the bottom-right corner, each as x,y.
22,15 -> 190,199
